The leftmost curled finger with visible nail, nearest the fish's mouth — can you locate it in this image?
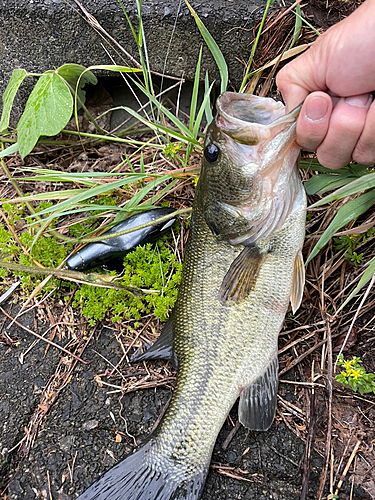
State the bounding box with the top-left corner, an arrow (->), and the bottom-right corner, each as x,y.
297,92 -> 332,151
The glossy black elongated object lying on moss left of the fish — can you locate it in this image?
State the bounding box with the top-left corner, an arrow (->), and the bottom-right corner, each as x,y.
66,208 -> 176,271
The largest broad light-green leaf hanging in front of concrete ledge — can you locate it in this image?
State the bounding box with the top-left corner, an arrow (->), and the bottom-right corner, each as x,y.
17,71 -> 73,158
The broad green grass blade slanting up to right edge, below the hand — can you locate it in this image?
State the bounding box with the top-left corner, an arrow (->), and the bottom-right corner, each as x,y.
306,190 -> 375,264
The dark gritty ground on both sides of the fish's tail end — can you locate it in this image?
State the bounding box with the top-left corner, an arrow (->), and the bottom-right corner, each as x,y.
0,306 -> 370,500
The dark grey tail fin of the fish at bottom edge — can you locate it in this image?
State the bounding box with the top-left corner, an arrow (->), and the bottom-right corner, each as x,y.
77,441 -> 208,500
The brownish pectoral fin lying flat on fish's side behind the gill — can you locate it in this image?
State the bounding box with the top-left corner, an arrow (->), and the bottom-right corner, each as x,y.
219,245 -> 265,304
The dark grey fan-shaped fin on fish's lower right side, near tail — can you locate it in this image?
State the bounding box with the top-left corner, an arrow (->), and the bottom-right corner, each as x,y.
238,353 -> 279,431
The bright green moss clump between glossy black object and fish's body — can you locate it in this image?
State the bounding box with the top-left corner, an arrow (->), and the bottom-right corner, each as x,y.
73,238 -> 182,325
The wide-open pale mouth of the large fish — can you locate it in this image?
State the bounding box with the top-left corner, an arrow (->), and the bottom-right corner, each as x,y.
216,92 -> 302,146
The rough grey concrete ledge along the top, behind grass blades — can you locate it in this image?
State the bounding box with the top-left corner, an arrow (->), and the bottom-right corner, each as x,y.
0,0 -> 268,124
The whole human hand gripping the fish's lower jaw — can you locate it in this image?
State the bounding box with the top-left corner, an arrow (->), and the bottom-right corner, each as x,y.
276,0 -> 375,169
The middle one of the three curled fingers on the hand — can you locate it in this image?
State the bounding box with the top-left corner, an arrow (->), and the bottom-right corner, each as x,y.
317,94 -> 371,169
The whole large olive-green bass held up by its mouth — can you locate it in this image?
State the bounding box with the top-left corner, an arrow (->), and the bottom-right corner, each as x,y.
79,92 -> 306,500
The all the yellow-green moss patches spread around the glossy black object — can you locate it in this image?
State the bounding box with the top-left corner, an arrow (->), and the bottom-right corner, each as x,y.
0,196 -> 182,328
